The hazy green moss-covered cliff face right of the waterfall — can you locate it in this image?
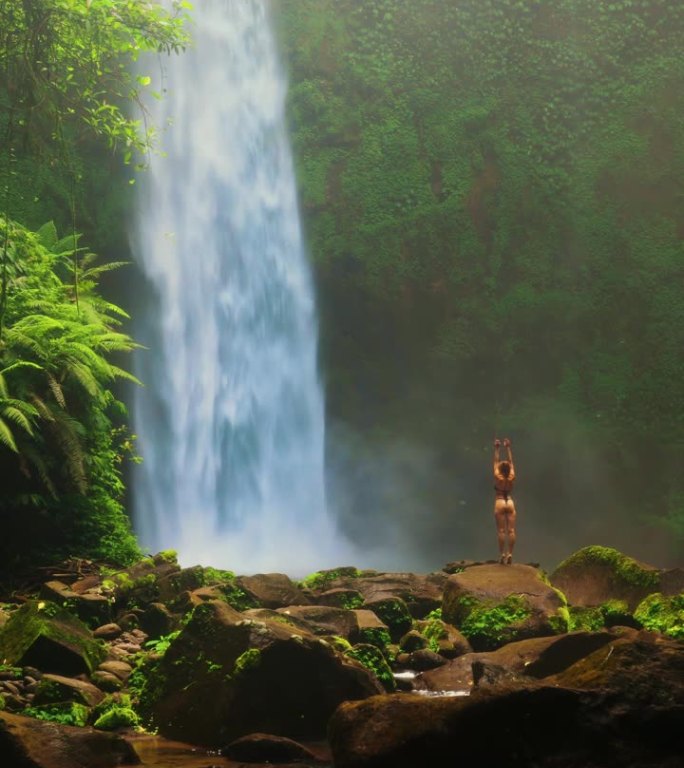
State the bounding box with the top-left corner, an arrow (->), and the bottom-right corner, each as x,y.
276,0 -> 684,558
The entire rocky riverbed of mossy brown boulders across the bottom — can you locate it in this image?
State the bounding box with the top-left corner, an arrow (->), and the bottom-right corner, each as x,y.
0,547 -> 684,768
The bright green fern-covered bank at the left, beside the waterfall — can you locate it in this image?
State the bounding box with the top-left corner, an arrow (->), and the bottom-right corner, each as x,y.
0,219 -> 138,565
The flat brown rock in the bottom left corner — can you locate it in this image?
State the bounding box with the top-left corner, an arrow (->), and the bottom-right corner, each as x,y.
0,712 -> 140,768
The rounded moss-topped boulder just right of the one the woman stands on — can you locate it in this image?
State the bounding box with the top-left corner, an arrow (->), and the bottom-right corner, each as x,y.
551,546 -> 660,611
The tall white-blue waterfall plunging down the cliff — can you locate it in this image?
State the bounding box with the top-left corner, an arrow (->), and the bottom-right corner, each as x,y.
133,0 -> 339,573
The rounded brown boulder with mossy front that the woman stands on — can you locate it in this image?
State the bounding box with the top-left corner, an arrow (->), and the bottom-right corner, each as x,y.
442,564 -> 569,651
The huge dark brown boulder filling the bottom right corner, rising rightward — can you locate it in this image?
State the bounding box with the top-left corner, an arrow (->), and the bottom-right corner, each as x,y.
329,633 -> 684,768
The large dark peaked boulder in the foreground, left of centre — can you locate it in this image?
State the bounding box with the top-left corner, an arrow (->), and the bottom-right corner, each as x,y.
148,601 -> 382,746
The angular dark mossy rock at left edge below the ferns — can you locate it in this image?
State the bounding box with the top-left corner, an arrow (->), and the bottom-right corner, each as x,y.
0,600 -> 106,676
